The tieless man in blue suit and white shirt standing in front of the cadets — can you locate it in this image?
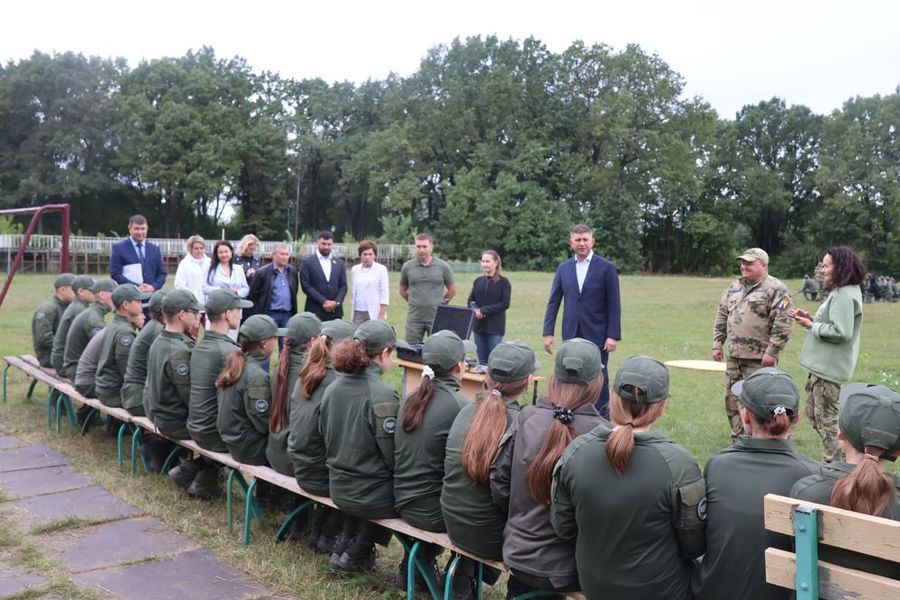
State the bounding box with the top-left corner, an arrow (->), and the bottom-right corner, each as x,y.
544,225 -> 622,416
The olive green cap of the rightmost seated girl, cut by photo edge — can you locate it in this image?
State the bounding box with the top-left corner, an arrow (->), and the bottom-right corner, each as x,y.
838,383 -> 900,455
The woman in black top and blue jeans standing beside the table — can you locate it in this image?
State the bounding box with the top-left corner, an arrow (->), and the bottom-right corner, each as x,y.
469,250 -> 512,366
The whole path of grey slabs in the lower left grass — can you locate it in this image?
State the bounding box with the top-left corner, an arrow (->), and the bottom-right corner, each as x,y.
0,435 -> 275,600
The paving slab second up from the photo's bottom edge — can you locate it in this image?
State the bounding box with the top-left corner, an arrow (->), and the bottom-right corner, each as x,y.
44,517 -> 197,573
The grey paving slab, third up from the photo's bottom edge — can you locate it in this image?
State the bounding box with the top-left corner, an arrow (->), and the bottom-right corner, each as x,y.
6,485 -> 140,528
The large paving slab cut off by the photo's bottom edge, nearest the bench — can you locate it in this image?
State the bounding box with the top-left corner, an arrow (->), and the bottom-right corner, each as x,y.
73,549 -> 271,600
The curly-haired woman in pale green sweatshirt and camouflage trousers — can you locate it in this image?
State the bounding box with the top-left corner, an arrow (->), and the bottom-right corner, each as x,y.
789,246 -> 866,462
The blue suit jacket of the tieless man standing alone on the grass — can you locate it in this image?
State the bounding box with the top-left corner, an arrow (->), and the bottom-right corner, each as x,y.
544,253 -> 622,350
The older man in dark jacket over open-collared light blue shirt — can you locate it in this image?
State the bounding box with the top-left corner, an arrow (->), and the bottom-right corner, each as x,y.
247,244 -> 297,327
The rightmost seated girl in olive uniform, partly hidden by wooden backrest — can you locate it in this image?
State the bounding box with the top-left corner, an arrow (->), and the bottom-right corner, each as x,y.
791,383 -> 900,579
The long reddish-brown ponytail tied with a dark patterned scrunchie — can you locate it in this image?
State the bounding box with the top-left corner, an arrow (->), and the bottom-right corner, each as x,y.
526,375 -> 603,504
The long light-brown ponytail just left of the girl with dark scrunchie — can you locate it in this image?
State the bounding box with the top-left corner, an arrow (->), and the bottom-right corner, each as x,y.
462,375 -> 528,485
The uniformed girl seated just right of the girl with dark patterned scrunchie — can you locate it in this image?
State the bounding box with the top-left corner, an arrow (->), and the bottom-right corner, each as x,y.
551,356 -> 706,600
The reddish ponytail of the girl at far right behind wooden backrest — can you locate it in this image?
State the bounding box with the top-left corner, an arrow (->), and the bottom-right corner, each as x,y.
831,446 -> 895,517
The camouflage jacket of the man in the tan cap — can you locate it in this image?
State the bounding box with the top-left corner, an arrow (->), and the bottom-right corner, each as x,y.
713,276 -> 794,359
